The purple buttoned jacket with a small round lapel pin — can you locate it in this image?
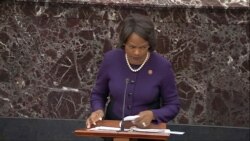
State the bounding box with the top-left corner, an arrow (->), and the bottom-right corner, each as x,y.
91,48 -> 180,123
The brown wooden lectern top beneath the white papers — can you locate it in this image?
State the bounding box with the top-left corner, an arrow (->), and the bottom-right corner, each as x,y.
74,120 -> 169,141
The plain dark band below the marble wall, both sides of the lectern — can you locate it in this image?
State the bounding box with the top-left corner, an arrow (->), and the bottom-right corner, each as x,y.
0,118 -> 249,141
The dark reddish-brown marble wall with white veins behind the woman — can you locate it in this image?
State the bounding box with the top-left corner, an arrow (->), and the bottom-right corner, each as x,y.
0,0 -> 250,127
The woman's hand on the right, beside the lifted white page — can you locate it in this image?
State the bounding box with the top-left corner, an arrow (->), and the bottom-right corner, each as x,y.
133,110 -> 154,128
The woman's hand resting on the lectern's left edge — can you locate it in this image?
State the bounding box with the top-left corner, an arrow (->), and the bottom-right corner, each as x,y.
86,110 -> 104,128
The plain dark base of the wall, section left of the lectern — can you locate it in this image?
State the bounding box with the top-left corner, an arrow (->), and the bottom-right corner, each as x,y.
0,118 -> 100,141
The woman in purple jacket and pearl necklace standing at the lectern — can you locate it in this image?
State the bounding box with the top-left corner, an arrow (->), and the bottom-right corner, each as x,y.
86,14 -> 180,128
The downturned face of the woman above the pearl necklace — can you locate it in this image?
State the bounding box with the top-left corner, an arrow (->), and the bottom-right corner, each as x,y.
125,33 -> 149,65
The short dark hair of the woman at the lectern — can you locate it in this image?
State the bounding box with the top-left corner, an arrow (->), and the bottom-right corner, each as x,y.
118,14 -> 156,51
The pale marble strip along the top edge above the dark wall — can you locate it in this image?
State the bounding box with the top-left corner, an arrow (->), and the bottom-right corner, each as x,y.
17,0 -> 250,8
